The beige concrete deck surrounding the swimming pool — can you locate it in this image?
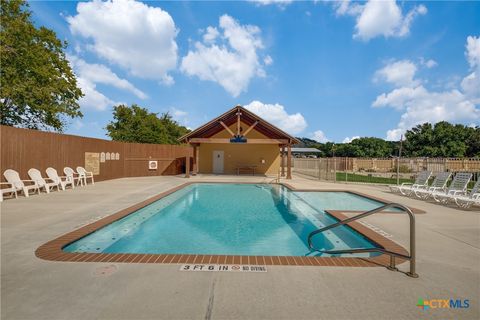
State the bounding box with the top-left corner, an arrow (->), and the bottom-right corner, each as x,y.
1,176 -> 480,319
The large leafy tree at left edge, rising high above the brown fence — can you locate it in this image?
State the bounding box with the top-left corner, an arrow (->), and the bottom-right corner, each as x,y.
0,0 -> 82,131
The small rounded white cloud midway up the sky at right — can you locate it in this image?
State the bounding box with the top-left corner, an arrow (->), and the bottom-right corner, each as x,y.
374,60 -> 418,86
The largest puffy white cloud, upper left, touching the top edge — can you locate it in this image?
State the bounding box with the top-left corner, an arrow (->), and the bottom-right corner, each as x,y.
67,0 -> 177,84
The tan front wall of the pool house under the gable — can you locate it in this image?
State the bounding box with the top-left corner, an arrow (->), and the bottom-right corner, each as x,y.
198,123 -> 280,175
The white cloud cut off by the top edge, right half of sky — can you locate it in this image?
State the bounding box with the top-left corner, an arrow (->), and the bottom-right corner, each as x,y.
334,0 -> 427,41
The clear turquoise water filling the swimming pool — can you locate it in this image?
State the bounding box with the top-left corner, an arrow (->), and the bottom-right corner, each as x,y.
64,184 -> 388,256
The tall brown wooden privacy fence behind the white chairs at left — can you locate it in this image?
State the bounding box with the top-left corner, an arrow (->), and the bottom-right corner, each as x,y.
0,126 -> 193,181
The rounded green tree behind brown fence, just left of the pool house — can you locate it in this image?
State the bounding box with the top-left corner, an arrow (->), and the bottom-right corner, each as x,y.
106,104 -> 188,144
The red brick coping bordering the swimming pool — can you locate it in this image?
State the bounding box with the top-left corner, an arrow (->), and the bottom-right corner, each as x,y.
35,181 -> 418,267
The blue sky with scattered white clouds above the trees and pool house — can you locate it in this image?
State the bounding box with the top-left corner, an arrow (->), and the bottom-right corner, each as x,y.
30,0 -> 480,142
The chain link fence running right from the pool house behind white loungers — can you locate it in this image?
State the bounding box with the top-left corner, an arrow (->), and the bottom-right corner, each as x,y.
292,157 -> 480,186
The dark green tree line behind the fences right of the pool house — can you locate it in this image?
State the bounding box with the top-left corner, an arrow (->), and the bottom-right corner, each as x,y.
299,121 -> 480,158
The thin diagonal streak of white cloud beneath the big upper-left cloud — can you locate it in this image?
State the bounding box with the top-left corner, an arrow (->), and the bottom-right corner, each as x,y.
68,55 -> 147,99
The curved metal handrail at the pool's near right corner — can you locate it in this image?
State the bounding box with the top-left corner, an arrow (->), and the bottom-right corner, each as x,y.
308,203 -> 418,278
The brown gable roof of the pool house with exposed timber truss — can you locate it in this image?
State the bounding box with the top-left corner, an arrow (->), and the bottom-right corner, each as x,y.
178,106 -> 300,144
